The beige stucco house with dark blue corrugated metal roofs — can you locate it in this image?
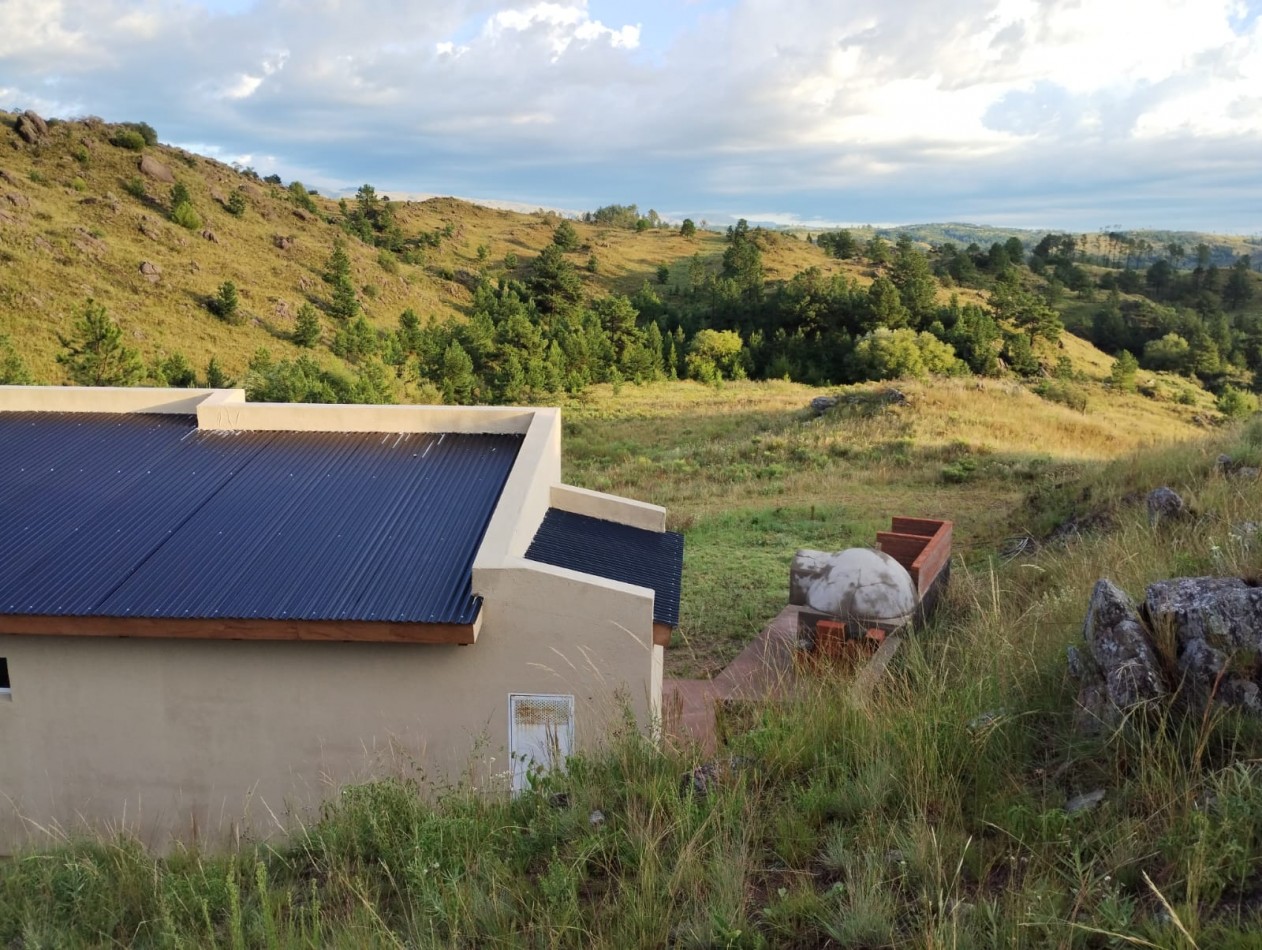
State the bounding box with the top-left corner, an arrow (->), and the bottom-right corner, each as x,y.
0,386 -> 683,853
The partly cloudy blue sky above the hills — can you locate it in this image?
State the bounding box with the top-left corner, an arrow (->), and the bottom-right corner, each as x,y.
0,0 -> 1262,235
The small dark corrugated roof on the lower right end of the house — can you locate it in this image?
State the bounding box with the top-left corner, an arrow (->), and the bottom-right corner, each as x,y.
526,508 -> 684,627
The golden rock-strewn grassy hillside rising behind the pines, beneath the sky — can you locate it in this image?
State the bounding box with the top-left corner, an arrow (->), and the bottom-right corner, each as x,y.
0,114 -> 842,382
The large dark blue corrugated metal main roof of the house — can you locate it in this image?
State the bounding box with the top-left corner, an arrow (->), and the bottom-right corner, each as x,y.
0,413 -> 521,623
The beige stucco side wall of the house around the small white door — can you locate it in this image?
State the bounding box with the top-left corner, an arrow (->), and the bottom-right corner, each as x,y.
0,566 -> 661,853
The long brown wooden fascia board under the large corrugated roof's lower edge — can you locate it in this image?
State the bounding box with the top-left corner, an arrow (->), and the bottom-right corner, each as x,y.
0,614 -> 482,645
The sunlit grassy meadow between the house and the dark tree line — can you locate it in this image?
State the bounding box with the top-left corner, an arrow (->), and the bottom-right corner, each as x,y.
563,370 -> 1213,675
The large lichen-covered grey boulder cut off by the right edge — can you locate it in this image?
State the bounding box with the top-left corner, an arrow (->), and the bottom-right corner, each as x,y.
1143,578 -> 1262,714
